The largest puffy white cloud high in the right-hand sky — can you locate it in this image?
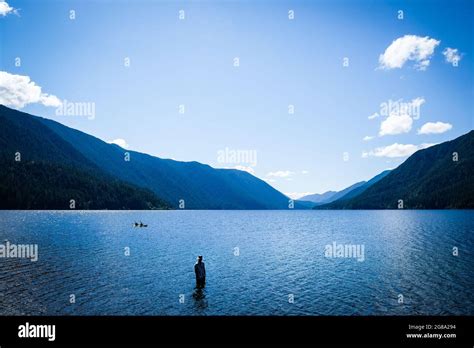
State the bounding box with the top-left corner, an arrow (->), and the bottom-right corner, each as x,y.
379,35 -> 440,70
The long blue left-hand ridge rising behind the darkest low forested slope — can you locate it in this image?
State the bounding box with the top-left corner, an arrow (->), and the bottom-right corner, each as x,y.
0,106 -> 305,209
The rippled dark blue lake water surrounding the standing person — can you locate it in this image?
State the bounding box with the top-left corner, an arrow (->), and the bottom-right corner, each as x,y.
0,211 -> 474,315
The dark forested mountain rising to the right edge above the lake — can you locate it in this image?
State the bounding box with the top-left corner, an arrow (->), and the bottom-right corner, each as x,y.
315,131 -> 474,209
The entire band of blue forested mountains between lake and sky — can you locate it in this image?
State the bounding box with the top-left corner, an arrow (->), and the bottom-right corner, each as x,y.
0,105 -> 474,209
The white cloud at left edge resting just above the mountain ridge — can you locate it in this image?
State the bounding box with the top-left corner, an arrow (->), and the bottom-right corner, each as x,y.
0,71 -> 62,109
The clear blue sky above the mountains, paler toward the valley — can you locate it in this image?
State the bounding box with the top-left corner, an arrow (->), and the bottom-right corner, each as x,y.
0,0 -> 474,196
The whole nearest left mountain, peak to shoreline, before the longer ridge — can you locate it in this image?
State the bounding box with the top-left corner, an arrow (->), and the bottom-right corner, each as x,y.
0,106 -> 168,209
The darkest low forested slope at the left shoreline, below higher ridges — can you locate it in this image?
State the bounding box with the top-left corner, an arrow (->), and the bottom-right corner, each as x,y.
0,161 -> 168,210
